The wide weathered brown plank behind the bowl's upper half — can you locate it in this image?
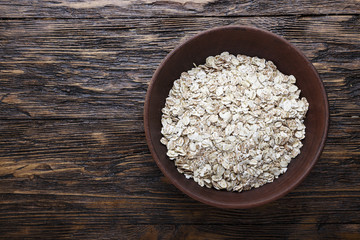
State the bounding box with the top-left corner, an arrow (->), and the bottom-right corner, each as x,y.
0,16 -> 360,120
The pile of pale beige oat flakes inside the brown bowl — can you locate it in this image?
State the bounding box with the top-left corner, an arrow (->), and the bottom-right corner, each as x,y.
161,52 -> 309,192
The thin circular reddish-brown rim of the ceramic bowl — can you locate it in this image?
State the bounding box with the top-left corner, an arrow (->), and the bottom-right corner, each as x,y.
143,25 -> 330,209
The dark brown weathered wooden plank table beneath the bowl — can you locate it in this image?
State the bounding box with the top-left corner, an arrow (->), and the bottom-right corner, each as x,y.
0,0 -> 360,239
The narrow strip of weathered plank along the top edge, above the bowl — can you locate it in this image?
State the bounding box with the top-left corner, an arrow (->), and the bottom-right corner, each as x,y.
0,0 -> 360,19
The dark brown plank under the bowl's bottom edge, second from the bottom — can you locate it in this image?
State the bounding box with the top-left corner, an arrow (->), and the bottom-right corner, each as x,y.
0,194 -> 360,230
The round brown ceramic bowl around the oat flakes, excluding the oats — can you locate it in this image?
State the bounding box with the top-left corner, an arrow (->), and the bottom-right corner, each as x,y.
144,26 -> 329,208
